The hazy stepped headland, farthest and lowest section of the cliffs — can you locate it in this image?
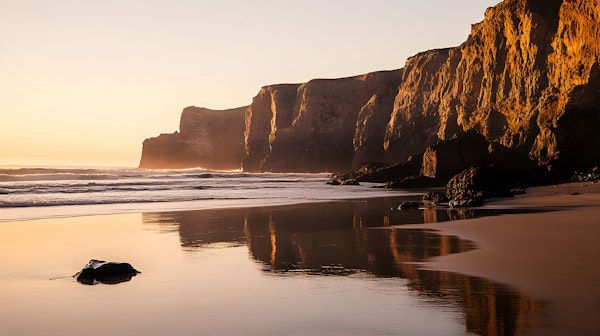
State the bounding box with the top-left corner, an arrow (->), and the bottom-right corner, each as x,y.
140,106 -> 247,170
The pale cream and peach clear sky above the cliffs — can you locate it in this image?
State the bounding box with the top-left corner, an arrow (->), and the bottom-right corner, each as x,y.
0,0 -> 499,167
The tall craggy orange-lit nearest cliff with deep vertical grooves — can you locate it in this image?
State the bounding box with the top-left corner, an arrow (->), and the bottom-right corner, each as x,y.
384,0 -> 600,173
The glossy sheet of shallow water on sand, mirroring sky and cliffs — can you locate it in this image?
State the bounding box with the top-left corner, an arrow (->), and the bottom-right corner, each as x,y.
0,199 -> 543,335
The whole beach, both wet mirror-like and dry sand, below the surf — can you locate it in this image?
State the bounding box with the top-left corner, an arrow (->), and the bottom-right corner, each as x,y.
0,183 -> 600,336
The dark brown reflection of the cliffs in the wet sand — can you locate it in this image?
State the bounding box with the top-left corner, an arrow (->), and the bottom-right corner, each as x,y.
143,199 -> 541,335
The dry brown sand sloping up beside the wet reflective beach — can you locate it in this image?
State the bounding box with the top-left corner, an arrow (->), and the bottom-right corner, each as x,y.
405,182 -> 600,335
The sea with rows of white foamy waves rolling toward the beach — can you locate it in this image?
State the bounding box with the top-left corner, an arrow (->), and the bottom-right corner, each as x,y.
0,167 -> 414,221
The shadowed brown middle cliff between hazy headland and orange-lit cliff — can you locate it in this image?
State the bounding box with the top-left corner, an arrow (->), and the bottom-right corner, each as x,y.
243,70 -> 401,172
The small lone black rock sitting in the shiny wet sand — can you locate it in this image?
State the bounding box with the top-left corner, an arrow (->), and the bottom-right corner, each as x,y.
74,259 -> 141,285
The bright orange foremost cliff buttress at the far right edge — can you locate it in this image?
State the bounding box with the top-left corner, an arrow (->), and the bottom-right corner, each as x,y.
532,0 -> 600,168
